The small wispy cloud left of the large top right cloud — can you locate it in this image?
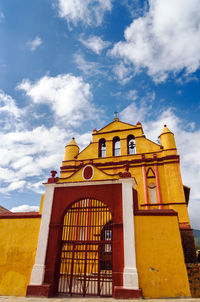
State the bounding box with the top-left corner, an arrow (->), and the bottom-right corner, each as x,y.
79,36 -> 110,55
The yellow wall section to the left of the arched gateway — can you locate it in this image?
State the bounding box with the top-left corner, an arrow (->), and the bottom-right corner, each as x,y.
0,218 -> 40,296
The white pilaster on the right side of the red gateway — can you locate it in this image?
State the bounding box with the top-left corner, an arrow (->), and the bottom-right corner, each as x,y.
122,179 -> 139,289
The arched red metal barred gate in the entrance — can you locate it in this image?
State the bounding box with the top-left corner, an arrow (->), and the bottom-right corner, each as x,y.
58,198 -> 112,297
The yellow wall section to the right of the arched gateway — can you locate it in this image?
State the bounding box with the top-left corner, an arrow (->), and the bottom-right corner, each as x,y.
135,216 -> 191,298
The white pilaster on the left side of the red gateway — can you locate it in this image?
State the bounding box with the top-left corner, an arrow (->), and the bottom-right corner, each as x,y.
30,184 -> 54,285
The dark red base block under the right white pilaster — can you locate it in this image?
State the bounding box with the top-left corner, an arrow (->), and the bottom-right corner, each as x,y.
113,286 -> 142,299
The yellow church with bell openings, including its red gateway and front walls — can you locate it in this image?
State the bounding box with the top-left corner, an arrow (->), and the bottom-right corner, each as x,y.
0,118 -> 196,298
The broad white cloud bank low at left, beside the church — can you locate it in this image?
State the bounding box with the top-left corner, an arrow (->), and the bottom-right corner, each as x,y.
0,126 -> 72,194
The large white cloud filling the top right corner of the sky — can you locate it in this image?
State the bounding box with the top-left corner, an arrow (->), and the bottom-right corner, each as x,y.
110,0 -> 200,82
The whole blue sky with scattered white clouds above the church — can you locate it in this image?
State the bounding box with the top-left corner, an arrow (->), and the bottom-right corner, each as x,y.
0,0 -> 200,229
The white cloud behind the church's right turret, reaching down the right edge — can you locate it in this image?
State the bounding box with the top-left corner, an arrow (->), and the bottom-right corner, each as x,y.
120,99 -> 200,229
